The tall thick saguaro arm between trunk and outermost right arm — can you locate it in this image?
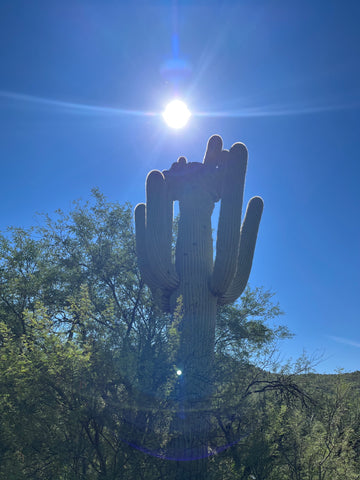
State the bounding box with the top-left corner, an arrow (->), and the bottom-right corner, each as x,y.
210,143 -> 248,297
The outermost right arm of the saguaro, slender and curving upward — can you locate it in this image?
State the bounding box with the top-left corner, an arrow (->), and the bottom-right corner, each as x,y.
218,197 -> 264,305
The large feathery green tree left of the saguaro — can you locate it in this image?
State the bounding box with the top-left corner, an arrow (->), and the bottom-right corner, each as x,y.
0,191 -> 174,478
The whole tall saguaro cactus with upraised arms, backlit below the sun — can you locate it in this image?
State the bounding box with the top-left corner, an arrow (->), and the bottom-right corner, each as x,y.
135,135 -> 263,468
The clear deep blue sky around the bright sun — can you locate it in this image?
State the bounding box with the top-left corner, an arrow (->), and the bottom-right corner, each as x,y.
0,0 -> 360,372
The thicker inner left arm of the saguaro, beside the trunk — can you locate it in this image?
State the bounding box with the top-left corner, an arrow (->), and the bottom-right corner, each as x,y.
145,170 -> 179,290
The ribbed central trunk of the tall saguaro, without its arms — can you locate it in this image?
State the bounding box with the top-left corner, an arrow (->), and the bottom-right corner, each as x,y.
173,202 -> 217,472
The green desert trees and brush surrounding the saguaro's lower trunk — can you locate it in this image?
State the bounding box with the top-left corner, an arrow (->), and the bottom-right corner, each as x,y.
0,190 -> 360,480
